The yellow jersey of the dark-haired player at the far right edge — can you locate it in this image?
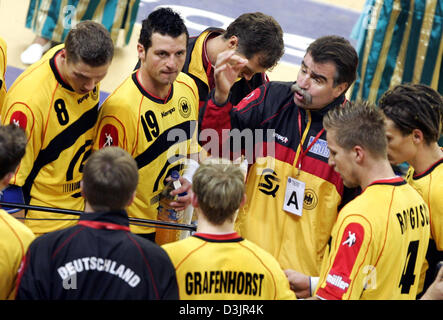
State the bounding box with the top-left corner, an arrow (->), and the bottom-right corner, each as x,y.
406,159 -> 443,292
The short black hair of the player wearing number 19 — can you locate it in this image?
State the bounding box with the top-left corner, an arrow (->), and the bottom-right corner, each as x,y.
138,8 -> 189,50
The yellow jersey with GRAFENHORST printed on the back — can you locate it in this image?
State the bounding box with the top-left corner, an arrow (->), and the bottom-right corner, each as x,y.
162,233 -> 296,300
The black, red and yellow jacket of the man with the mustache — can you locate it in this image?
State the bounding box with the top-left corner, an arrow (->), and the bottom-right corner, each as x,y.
200,81 -> 353,276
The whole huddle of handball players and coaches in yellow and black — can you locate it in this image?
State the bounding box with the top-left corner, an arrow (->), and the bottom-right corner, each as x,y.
0,8 -> 443,300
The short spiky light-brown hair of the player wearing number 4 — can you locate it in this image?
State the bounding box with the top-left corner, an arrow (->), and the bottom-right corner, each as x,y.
323,101 -> 387,158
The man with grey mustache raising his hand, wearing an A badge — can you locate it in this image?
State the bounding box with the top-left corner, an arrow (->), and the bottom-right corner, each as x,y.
201,36 -> 358,275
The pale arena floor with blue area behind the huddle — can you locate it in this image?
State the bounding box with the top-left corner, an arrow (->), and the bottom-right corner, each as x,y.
0,0 -> 365,100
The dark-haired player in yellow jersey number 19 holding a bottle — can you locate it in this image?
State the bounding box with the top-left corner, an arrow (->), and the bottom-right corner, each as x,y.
93,8 -> 199,240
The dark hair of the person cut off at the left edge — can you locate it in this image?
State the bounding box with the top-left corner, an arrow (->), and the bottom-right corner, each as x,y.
0,124 -> 27,179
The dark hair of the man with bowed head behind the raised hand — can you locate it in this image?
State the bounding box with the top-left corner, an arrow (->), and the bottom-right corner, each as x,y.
223,12 -> 285,69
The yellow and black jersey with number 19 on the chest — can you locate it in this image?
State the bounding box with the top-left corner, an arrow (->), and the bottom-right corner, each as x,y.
93,70 -> 199,233
